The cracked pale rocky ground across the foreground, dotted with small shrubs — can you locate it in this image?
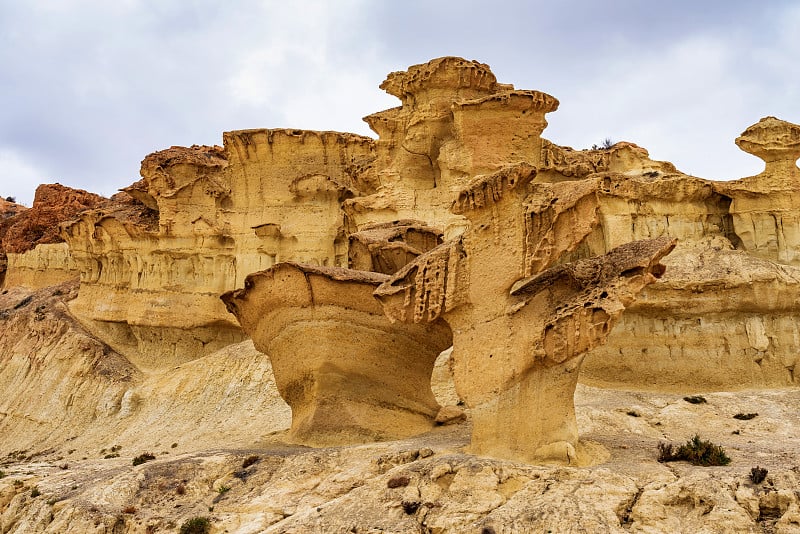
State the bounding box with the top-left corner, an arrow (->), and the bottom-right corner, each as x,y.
0,376 -> 800,534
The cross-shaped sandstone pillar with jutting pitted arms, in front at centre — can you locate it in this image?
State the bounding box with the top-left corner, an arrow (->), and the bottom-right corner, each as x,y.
376,164 -> 675,463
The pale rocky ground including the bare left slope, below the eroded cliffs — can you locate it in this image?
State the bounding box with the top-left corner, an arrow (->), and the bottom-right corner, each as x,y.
0,283 -> 800,534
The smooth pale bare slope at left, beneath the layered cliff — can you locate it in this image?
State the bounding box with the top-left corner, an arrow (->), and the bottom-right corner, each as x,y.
0,281 -> 289,459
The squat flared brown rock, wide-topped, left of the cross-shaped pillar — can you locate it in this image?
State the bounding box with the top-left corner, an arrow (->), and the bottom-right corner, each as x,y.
222,263 -> 452,446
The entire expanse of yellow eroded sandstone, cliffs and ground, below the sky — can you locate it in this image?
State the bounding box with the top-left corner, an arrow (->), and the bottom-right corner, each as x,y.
0,58 -> 800,534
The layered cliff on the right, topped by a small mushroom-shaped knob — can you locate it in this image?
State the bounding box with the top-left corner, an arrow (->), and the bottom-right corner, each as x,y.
580,118 -> 800,391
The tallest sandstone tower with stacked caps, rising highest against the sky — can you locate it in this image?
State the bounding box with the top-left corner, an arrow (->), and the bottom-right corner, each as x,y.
345,57 -> 558,238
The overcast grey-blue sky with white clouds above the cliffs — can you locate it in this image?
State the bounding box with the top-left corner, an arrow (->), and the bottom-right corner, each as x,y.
0,0 -> 800,205
